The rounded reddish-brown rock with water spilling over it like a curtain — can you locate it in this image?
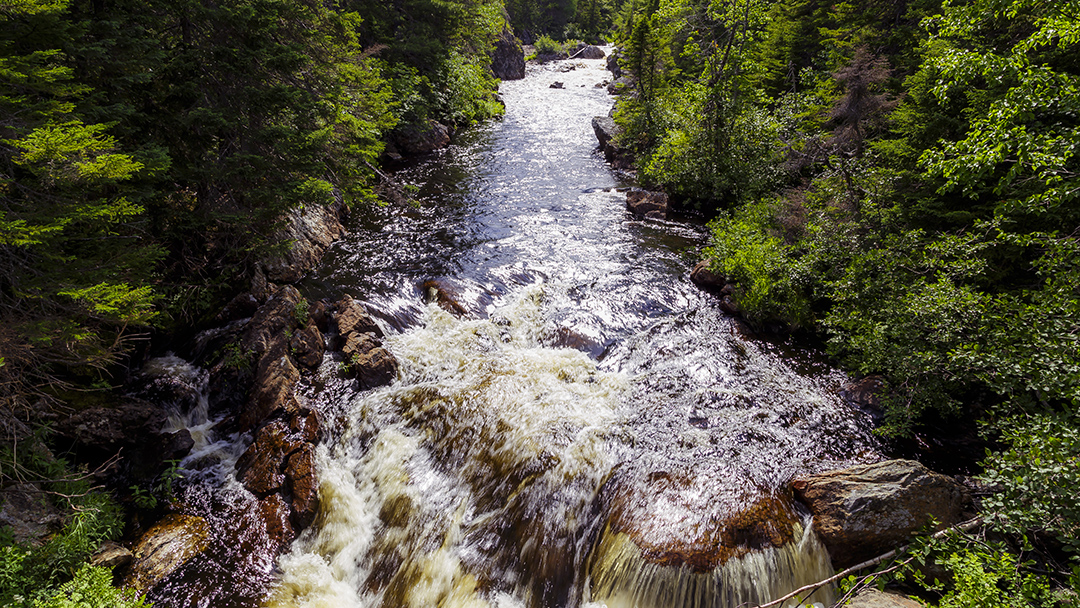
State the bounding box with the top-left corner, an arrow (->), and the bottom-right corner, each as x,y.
589,471 -> 832,606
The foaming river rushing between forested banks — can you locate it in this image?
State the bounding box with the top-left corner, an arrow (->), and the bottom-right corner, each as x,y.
250,52 -> 873,608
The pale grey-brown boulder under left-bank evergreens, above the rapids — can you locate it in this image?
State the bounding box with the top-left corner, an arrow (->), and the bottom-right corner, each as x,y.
264,198 -> 349,283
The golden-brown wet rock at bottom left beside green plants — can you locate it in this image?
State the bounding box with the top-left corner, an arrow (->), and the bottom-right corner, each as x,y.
125,514 -> 211,592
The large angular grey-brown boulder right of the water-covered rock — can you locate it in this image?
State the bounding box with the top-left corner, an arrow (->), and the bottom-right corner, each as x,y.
793,460 -> 967,569
